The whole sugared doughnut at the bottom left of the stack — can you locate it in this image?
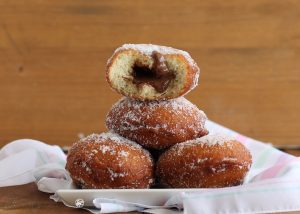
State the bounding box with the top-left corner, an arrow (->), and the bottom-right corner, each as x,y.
66,133 -> 154,189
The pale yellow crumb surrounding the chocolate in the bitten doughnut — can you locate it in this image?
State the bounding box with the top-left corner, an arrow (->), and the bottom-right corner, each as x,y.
108,49 -> 188,99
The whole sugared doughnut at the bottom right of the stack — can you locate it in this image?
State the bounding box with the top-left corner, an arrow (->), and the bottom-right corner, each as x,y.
156,135 -> 252,188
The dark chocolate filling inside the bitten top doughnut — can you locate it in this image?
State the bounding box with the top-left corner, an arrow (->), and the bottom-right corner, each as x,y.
132,52 -> 175,93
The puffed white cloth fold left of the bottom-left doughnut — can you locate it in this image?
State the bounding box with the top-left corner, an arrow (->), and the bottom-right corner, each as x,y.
0,139 -> 66,187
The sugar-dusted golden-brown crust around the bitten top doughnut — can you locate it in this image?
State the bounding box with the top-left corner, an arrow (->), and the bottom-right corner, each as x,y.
105,45 -> 200,100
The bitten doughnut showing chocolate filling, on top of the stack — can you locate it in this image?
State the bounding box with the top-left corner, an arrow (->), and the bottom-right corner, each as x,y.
106,44 -> 200,100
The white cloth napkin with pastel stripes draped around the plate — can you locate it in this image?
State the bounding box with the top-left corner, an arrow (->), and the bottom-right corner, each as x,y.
0,121 -> 300,214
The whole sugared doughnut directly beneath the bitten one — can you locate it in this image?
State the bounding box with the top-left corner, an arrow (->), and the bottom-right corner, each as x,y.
106,97 -> 208,149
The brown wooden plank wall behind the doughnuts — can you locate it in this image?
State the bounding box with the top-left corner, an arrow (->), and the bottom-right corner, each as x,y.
0,0 -> 300,146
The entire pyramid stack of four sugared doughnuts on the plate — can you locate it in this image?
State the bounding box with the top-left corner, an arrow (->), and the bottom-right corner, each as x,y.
66,44 -> 252,189
